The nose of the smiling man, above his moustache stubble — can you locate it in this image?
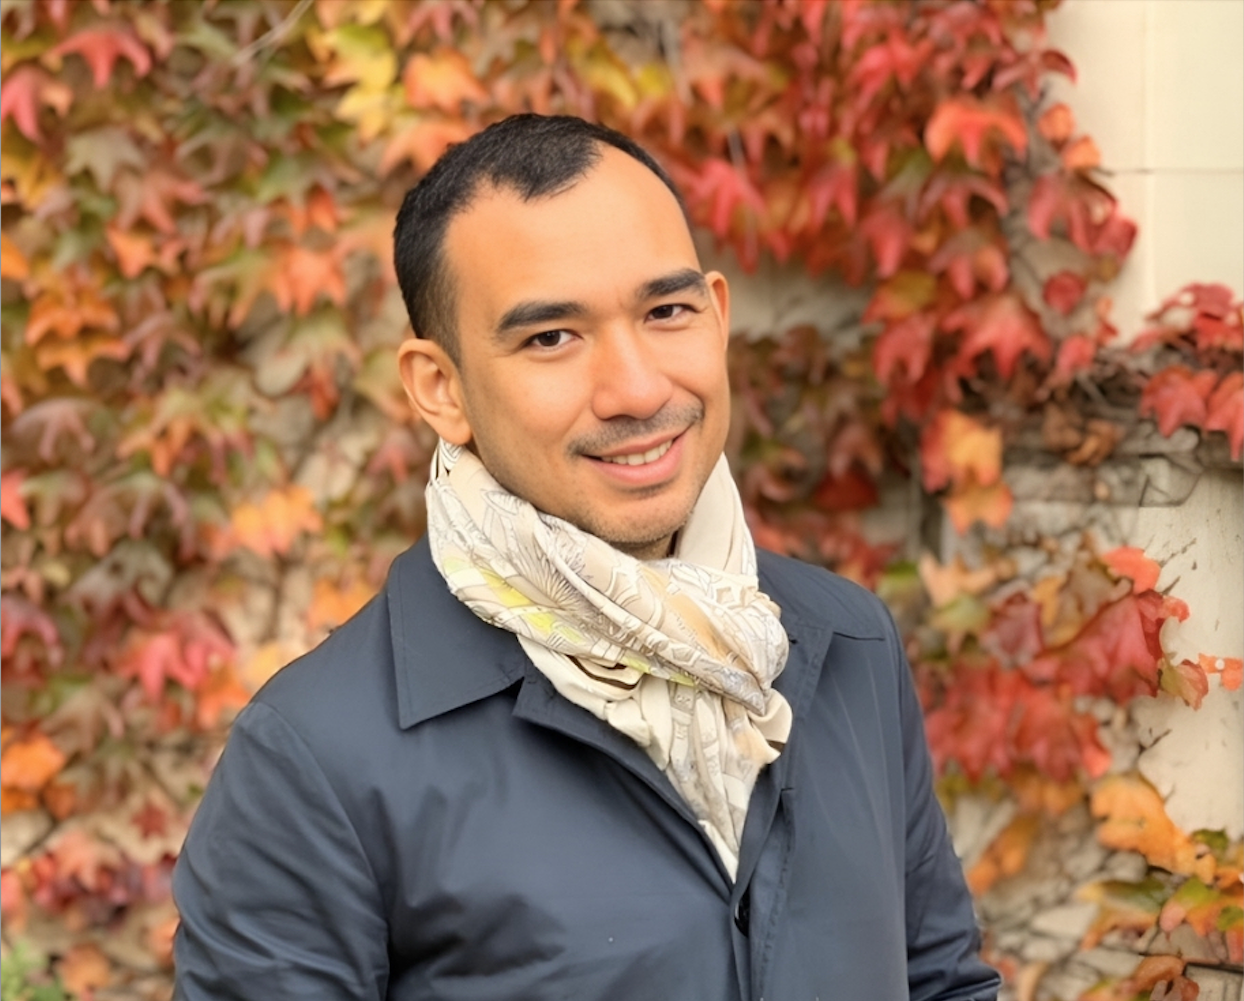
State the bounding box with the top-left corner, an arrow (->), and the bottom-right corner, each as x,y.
592,325 -> 673,420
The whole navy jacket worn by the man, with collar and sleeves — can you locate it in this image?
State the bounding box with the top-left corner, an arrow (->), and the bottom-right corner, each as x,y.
174,542 -> 998,1001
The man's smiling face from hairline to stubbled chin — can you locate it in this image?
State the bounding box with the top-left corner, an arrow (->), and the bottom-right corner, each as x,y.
413,148 -> 729,558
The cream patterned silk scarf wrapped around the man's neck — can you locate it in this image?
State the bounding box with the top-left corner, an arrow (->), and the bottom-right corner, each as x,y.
427,441 -> 791,875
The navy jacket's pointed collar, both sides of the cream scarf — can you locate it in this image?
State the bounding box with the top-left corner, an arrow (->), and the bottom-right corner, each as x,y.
386,537 -> 841,731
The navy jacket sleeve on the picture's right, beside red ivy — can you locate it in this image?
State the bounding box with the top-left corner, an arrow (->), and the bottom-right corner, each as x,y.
889,604 -> 1000,1001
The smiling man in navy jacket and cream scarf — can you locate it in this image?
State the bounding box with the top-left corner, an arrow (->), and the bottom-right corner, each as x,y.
174,116 -> 998,1001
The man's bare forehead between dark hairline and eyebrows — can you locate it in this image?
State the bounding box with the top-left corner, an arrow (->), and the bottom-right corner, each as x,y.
445,147 -> 699,333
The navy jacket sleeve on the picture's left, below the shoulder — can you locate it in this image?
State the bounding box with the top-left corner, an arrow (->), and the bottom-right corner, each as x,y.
173,703 -> 388,1001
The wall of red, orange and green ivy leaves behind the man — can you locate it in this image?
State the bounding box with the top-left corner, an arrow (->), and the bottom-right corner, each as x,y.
0,0 -> 1244,999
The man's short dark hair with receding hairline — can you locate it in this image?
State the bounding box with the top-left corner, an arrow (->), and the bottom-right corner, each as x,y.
393,114 -> 687,363
